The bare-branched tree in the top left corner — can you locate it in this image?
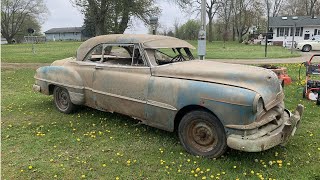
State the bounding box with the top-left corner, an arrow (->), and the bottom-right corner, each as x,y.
1,0 -> 47,43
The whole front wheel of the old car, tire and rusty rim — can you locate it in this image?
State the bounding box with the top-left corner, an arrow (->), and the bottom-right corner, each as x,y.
178,110 -> 227,158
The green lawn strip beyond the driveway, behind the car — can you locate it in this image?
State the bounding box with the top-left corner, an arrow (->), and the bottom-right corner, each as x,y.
1,41 -> 300,63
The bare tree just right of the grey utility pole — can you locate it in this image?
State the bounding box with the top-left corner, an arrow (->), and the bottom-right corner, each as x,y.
175,0 -> 223,42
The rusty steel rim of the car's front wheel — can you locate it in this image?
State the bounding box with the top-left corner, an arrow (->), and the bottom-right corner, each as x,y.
187,119 -> 218,152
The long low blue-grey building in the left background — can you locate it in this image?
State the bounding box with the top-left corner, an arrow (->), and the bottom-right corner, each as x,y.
44,27 -> 84,41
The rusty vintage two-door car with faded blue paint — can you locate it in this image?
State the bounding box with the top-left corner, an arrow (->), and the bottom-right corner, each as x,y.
33,35 -> 303,157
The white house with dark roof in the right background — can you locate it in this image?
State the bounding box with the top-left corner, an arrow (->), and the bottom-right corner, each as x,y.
269,16 -> 320,46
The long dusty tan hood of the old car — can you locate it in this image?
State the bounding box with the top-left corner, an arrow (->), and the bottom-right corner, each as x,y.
152,60 -> 283,109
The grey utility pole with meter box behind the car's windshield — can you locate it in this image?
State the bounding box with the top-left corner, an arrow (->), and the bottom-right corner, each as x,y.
198,0 -> 206,60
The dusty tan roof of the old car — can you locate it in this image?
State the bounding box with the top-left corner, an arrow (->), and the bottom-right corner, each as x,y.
77,34 -> 195,61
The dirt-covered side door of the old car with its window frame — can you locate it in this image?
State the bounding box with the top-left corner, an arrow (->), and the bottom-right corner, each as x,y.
93,45 -> 151,120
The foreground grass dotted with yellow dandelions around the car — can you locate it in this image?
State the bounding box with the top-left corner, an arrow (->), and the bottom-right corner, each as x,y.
1,64 -> 320,180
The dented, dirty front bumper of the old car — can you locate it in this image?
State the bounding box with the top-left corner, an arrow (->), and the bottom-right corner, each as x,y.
227,104 -> 304,152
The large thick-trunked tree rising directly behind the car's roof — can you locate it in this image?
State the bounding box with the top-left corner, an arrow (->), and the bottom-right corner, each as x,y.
71,0 -> 160,35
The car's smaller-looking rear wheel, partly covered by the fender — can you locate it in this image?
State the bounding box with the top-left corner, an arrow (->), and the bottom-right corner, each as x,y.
53,86 -> 76,114
